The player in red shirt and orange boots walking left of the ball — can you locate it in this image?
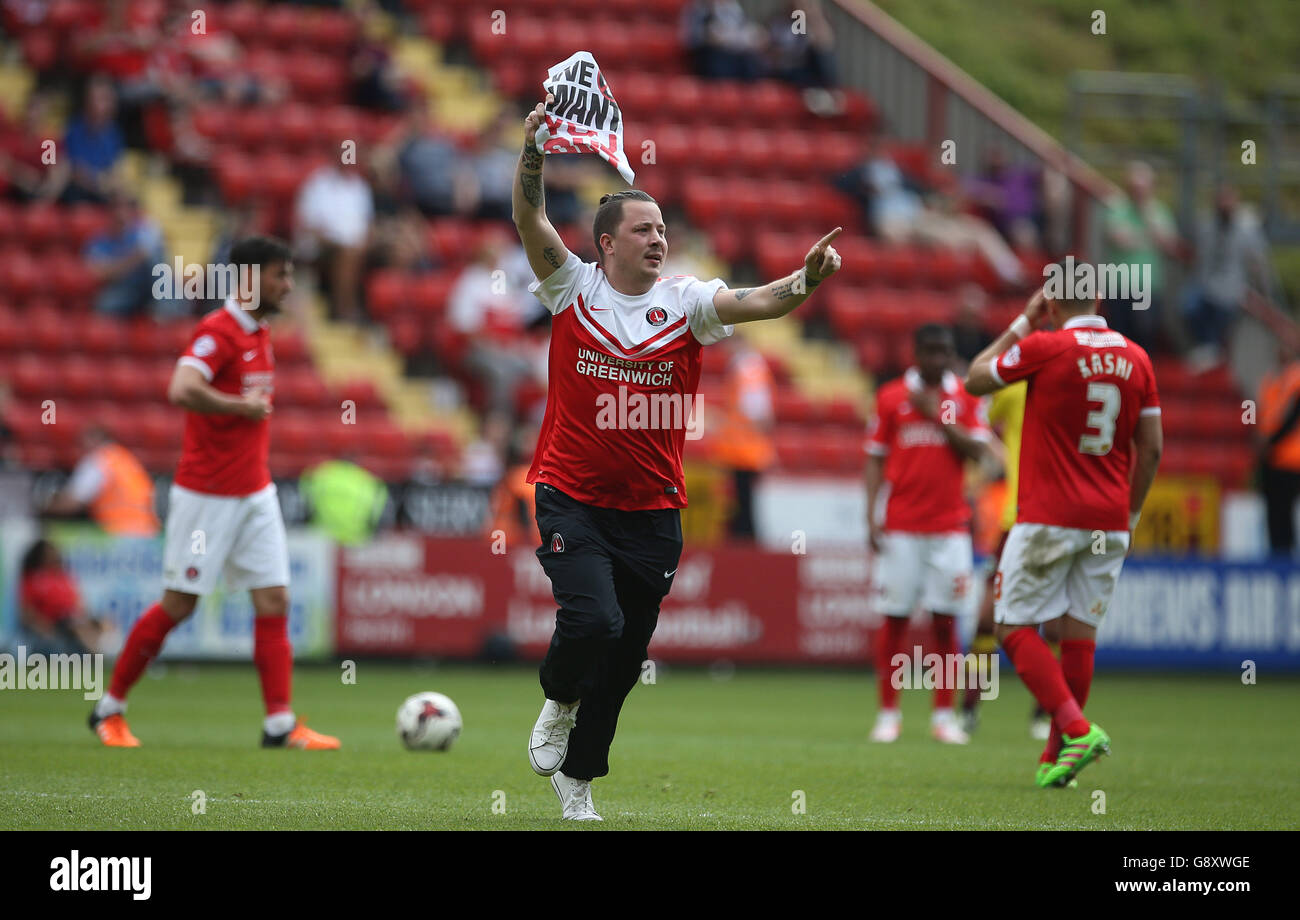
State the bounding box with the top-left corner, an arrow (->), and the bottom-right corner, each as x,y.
90,236 -> 339,750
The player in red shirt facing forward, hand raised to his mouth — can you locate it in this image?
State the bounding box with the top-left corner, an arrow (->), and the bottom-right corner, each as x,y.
867,324 -> 989,745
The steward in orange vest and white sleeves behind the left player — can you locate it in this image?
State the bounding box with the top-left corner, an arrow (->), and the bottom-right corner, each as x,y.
46,425 -> 161,537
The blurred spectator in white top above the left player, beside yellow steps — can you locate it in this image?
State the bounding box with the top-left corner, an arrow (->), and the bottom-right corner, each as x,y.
294,147 -> 374,325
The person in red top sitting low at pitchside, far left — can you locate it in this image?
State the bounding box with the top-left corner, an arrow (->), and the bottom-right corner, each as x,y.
18,538 -> 112,655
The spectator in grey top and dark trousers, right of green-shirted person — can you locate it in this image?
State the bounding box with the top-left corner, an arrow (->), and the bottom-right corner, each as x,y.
1184,185 -> 1273,370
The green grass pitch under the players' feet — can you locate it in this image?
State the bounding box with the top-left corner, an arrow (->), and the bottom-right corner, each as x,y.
0,661 -> 1300,830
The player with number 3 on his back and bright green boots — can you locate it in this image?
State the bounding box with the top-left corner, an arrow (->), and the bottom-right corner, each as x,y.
966,285 -> 1164,787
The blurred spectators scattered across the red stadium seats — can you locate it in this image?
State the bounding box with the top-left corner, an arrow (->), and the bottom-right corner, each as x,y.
0,0 -> 1300,556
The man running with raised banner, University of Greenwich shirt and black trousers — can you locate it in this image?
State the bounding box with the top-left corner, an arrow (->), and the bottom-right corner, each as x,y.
514,97 -> 840,821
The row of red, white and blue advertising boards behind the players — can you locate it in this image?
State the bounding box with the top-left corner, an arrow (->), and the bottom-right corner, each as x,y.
0,521 -> 1300,672
